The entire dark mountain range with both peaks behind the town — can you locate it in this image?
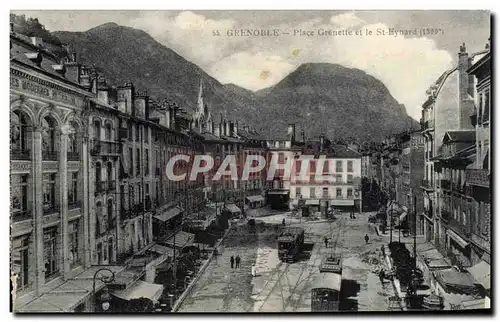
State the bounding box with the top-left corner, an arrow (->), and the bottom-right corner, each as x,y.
52,23 -> 417,139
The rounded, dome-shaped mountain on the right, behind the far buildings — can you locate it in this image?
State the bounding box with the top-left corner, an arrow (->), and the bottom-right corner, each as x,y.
250,63 -> 419,139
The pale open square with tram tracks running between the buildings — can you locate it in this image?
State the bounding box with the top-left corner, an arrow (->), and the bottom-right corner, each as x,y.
179,214 -> 394,312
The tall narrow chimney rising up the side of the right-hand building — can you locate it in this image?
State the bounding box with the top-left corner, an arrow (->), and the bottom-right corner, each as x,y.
458,43 -> 474,130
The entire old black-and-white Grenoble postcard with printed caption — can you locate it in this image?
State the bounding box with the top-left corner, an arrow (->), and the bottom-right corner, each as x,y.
10,10 -> 492,314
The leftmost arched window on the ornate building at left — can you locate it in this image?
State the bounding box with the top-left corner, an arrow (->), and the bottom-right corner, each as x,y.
10,111 -> 30,160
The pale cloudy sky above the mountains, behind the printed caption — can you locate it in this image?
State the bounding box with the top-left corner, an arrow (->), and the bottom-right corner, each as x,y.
13,10 -> 490,120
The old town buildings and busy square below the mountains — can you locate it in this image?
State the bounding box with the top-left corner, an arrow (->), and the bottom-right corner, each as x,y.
10,16 -> 491,313
